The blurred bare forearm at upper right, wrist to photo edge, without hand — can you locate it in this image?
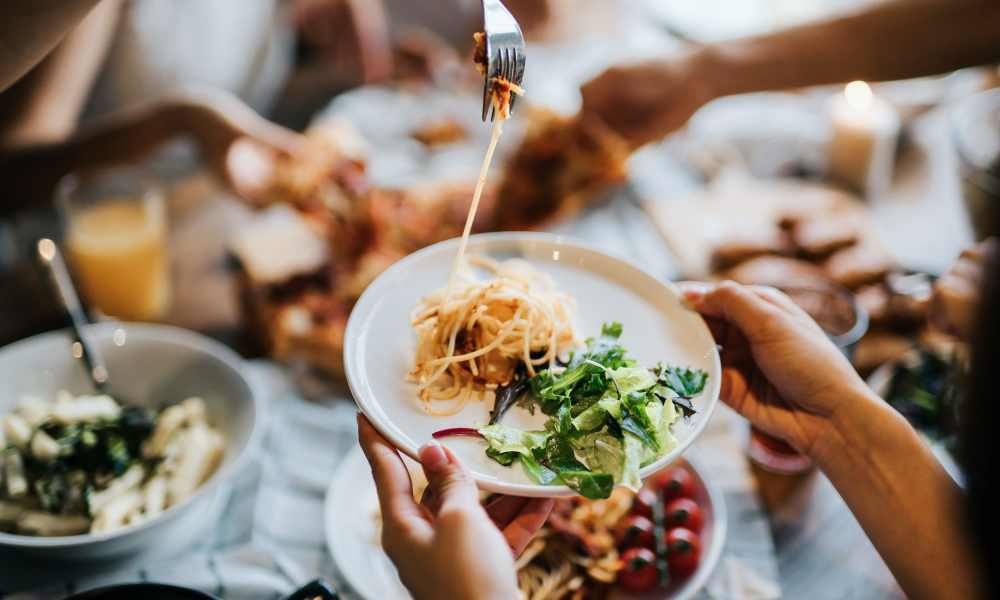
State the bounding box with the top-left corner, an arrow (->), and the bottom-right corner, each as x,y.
694,0 -> 1000,97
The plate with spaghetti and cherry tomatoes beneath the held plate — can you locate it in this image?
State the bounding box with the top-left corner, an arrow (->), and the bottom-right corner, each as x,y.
323,448 -> 727,600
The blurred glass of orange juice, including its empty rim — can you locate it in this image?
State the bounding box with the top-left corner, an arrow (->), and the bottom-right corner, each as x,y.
56,167 -> 170,321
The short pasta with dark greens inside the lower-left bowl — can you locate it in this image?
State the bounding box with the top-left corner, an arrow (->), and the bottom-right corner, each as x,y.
0,390 -> 225,536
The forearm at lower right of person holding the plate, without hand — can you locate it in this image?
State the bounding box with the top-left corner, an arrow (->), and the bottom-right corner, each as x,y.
814,390 -> 980,600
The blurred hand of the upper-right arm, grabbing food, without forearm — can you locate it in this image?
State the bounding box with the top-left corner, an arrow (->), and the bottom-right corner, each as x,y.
581,53 -> 714,148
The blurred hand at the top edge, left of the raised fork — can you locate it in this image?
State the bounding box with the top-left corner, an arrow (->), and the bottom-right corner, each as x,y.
293,0 -> 393,83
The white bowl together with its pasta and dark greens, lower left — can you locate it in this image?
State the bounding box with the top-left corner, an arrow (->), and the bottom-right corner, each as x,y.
0,323 -> 260,559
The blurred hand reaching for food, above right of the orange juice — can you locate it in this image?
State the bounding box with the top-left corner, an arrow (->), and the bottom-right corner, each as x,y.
175,89 -> 304,203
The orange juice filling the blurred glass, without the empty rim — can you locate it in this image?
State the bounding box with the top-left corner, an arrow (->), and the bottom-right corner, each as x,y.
66,198 -> 170,320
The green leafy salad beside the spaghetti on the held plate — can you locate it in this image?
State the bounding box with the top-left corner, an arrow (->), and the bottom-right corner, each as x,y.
441,323 -> 708,498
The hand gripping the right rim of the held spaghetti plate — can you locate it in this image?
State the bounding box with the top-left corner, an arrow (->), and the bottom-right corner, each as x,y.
680,281 -> 870,455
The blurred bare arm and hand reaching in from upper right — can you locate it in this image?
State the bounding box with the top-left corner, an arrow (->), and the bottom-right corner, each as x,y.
583,0 -> 1000,148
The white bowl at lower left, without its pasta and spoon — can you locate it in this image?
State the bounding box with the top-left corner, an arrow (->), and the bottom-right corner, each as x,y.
0,323 -> 262,560
